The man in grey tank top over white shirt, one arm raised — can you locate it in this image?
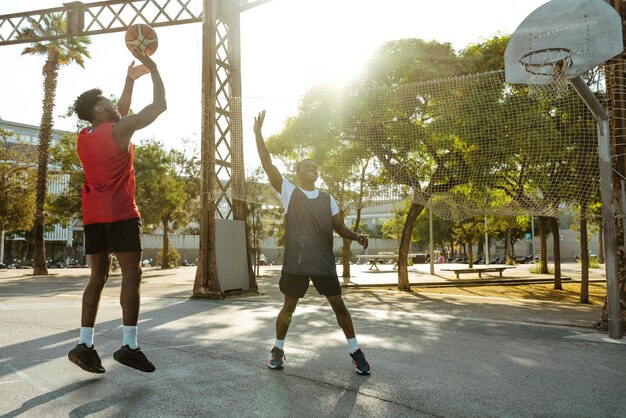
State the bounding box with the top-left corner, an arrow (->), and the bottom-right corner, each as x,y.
254,111 -> 370,374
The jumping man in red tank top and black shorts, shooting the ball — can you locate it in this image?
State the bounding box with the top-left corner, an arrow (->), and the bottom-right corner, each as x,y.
68,53 -> 167,373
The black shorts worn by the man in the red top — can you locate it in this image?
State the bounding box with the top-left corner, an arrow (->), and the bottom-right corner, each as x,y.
84,218 -> 143,254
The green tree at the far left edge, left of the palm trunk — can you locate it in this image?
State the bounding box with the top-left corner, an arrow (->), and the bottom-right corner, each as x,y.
0,129 -> 36,262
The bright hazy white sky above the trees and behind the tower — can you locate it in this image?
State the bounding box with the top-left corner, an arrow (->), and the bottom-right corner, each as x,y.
0,0 -> 547,165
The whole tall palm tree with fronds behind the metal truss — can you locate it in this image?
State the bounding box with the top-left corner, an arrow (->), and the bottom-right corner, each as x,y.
18,14 -> 91,275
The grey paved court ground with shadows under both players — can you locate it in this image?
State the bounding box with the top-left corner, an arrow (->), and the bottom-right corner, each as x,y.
0,265 -> 626,417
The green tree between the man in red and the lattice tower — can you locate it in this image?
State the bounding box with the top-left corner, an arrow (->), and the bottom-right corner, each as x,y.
135,140 -> 200,269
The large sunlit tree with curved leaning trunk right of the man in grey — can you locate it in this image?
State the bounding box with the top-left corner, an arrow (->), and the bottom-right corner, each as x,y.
346,39 -> 465,290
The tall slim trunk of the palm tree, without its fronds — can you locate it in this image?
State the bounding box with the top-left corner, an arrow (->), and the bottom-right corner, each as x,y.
33,51 -> 59,275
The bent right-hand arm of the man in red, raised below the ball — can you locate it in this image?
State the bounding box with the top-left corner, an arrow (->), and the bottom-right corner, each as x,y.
113,52 -> 167,150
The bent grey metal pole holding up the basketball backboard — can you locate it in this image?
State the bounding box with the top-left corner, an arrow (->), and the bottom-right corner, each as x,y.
570,77 -> 622,338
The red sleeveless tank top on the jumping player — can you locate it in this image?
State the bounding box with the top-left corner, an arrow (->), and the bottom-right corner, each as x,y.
77,122 -> 141,225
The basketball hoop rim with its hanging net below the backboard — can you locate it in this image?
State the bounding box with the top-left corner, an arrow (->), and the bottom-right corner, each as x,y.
519,48 -> 572,99
